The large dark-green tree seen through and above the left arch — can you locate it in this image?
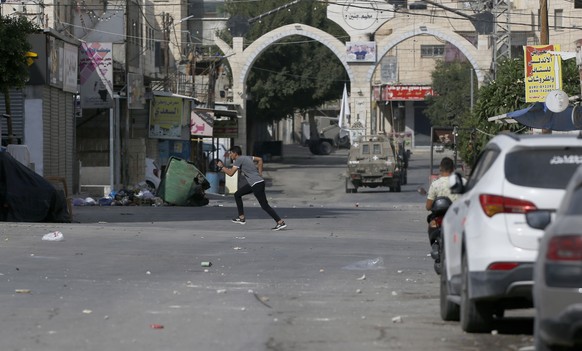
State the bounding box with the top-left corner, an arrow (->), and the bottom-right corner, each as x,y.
222,0 -> 348,121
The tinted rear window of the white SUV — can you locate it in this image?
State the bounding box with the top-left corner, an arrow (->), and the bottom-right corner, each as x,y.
505,147 -> 582,189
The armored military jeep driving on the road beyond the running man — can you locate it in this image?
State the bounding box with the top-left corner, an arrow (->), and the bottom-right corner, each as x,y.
346,135 -> 404,193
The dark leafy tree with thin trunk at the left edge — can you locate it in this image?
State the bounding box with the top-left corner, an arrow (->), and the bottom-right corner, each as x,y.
0,16 -> 37,142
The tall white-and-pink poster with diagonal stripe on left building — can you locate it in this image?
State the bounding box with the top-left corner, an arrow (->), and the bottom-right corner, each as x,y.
79,42 -> 113,108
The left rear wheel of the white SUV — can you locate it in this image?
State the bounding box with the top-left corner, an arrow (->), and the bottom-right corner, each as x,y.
461,255 -> 493,333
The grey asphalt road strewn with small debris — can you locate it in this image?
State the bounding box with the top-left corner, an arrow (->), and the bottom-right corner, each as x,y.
0,146 -> 533,351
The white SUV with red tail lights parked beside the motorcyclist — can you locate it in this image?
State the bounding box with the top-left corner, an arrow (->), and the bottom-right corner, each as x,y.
440,134 -> 582,332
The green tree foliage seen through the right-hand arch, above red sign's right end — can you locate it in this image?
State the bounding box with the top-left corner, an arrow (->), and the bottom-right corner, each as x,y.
425,61 -> 477,127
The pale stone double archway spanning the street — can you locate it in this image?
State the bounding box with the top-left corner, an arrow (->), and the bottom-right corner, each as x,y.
215,23 -> 492,149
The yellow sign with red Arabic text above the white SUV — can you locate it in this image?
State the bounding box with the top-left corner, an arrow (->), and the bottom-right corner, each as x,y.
523,45 -> 562,102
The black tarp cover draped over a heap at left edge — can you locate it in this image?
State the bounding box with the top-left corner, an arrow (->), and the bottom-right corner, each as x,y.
0,152 -> 70,223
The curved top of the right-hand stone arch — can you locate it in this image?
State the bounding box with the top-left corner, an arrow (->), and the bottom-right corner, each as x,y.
366,24 -> 492,85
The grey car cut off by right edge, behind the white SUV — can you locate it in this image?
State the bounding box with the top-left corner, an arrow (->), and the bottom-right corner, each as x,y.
526,166 -> 582,351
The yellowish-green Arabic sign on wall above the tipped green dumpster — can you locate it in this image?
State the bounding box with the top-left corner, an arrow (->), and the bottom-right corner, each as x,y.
149,96 -> 182,139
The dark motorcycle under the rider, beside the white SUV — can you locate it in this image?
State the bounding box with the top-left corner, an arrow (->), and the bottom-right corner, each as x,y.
418,188 -> 453,275
